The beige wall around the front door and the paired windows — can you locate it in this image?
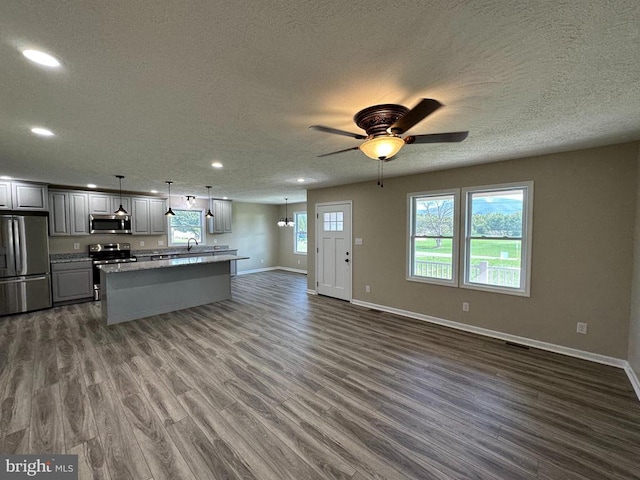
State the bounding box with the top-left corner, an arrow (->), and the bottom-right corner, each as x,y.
307,143 -> 638,358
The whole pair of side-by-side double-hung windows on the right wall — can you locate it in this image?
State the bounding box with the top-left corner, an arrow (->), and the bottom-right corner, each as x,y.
408,182 -> 533,296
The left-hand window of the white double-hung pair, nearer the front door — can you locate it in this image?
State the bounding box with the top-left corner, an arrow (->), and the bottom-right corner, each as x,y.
409,190 -> 459,285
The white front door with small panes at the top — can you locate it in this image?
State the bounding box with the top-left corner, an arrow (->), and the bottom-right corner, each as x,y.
316,202 -> 352,301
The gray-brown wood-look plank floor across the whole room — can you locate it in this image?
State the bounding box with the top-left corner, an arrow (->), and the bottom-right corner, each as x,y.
0,272 -> 640,480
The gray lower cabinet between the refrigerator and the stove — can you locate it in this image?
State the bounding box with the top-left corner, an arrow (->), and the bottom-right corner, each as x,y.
51,260 -> 93,303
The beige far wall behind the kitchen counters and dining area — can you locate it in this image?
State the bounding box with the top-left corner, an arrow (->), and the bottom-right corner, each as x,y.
49,197 -> 279,272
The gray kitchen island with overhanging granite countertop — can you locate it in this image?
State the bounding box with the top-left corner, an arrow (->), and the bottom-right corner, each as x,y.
99,255 -> 249,325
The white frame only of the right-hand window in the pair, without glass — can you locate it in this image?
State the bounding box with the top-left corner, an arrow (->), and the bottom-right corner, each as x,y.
460,181 -> 533,297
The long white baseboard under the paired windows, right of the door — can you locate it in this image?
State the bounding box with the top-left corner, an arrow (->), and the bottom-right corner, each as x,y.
351,300 -> 628,370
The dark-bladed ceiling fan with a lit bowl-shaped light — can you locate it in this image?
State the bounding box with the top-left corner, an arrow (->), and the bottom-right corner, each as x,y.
309,98 -> 469,162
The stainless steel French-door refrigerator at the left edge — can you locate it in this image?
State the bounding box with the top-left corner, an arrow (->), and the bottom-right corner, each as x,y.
0,213 -> 51,315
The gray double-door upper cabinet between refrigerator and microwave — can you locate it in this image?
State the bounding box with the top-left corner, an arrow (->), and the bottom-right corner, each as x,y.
49,190 -> 89,237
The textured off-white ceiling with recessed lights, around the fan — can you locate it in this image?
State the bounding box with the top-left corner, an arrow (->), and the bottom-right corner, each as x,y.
0,0 -> 640,203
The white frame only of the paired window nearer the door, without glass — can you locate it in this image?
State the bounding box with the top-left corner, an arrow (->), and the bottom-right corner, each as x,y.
407,188 -> 460,287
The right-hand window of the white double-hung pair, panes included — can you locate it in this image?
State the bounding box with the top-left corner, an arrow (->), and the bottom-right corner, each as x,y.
462,182 -> 533,296
